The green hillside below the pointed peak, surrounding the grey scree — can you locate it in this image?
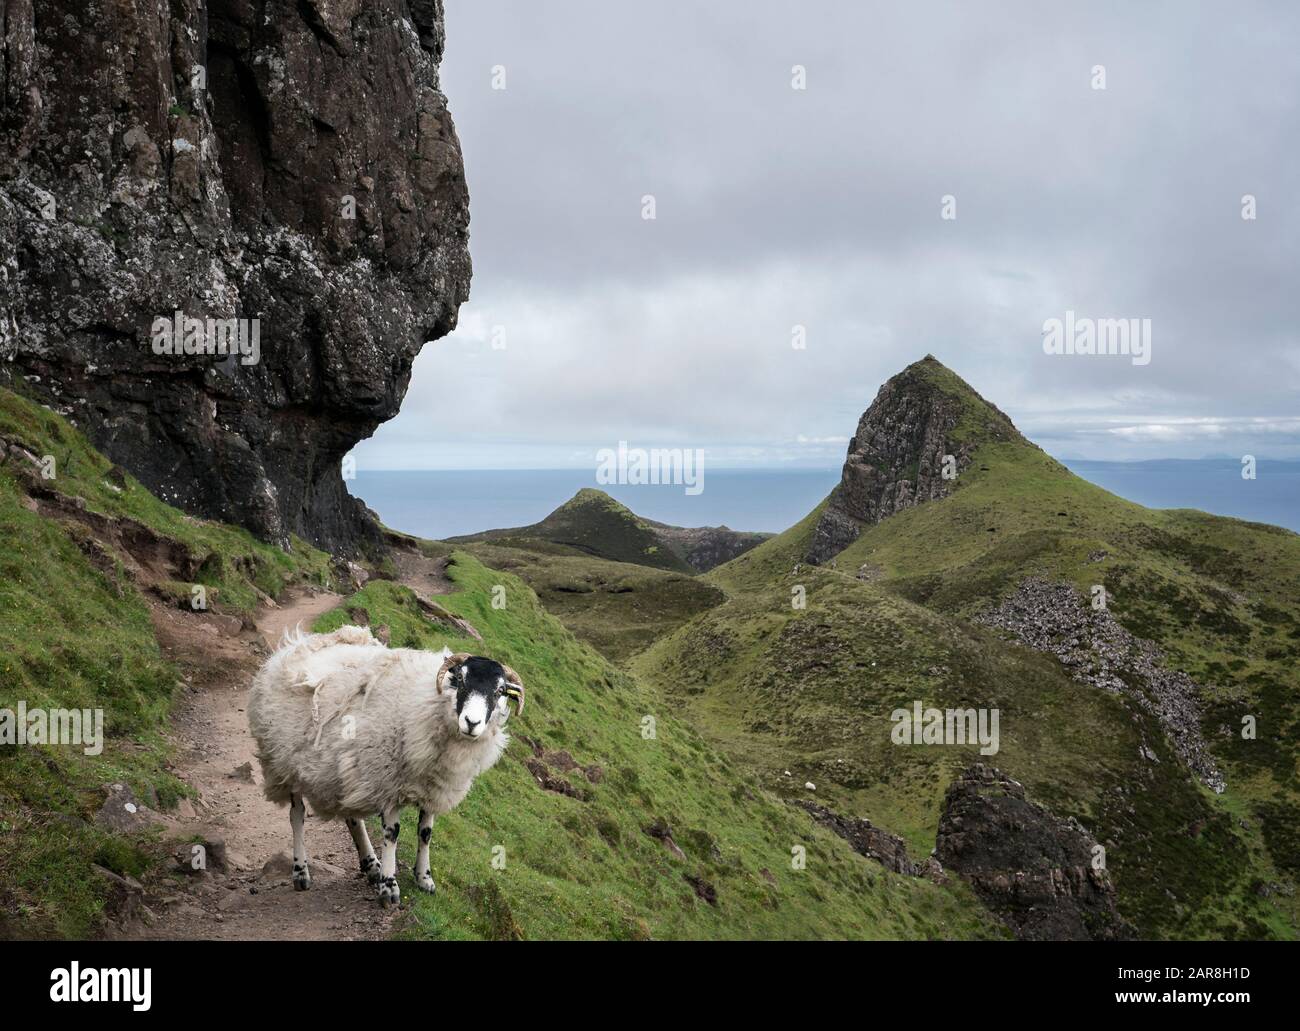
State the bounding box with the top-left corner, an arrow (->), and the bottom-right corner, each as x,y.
632,367 -> 1300,937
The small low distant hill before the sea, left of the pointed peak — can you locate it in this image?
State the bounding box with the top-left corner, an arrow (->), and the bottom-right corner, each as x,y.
451,488 -> 771,573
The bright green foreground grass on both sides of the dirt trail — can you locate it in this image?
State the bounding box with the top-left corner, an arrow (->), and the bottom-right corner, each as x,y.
0,393 -> 1001,937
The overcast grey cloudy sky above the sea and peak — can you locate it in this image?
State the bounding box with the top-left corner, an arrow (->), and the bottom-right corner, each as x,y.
356,0 -> 1300,469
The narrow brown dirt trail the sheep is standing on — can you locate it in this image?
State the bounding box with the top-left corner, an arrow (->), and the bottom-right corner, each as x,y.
108,589 -> 397,940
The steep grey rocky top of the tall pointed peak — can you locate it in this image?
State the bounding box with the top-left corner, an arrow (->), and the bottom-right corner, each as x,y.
807,355 -> 1023,563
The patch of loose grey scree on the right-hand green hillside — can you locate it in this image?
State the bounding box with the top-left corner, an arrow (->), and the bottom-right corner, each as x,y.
976,576 -> 1225,793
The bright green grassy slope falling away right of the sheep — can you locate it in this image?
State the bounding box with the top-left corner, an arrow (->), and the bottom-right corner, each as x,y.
316,564 -> 1000,939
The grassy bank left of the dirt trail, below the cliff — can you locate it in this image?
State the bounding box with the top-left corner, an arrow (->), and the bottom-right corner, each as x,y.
0,390 -> 326,937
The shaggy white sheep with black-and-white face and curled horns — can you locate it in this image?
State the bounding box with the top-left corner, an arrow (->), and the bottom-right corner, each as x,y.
248,627 -> 524,906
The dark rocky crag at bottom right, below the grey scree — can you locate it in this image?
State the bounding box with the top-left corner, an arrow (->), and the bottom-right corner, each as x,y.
935,763 -> 1131,941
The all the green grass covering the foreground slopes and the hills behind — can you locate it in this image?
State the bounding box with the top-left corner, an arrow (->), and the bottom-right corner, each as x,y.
0,363 -> 1300,939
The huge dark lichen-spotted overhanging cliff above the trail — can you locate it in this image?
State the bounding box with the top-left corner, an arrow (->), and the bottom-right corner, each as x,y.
0,0 -> 469,551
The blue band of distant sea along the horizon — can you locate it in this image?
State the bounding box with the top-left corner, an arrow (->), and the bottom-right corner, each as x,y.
348,459 -> 1300,540
